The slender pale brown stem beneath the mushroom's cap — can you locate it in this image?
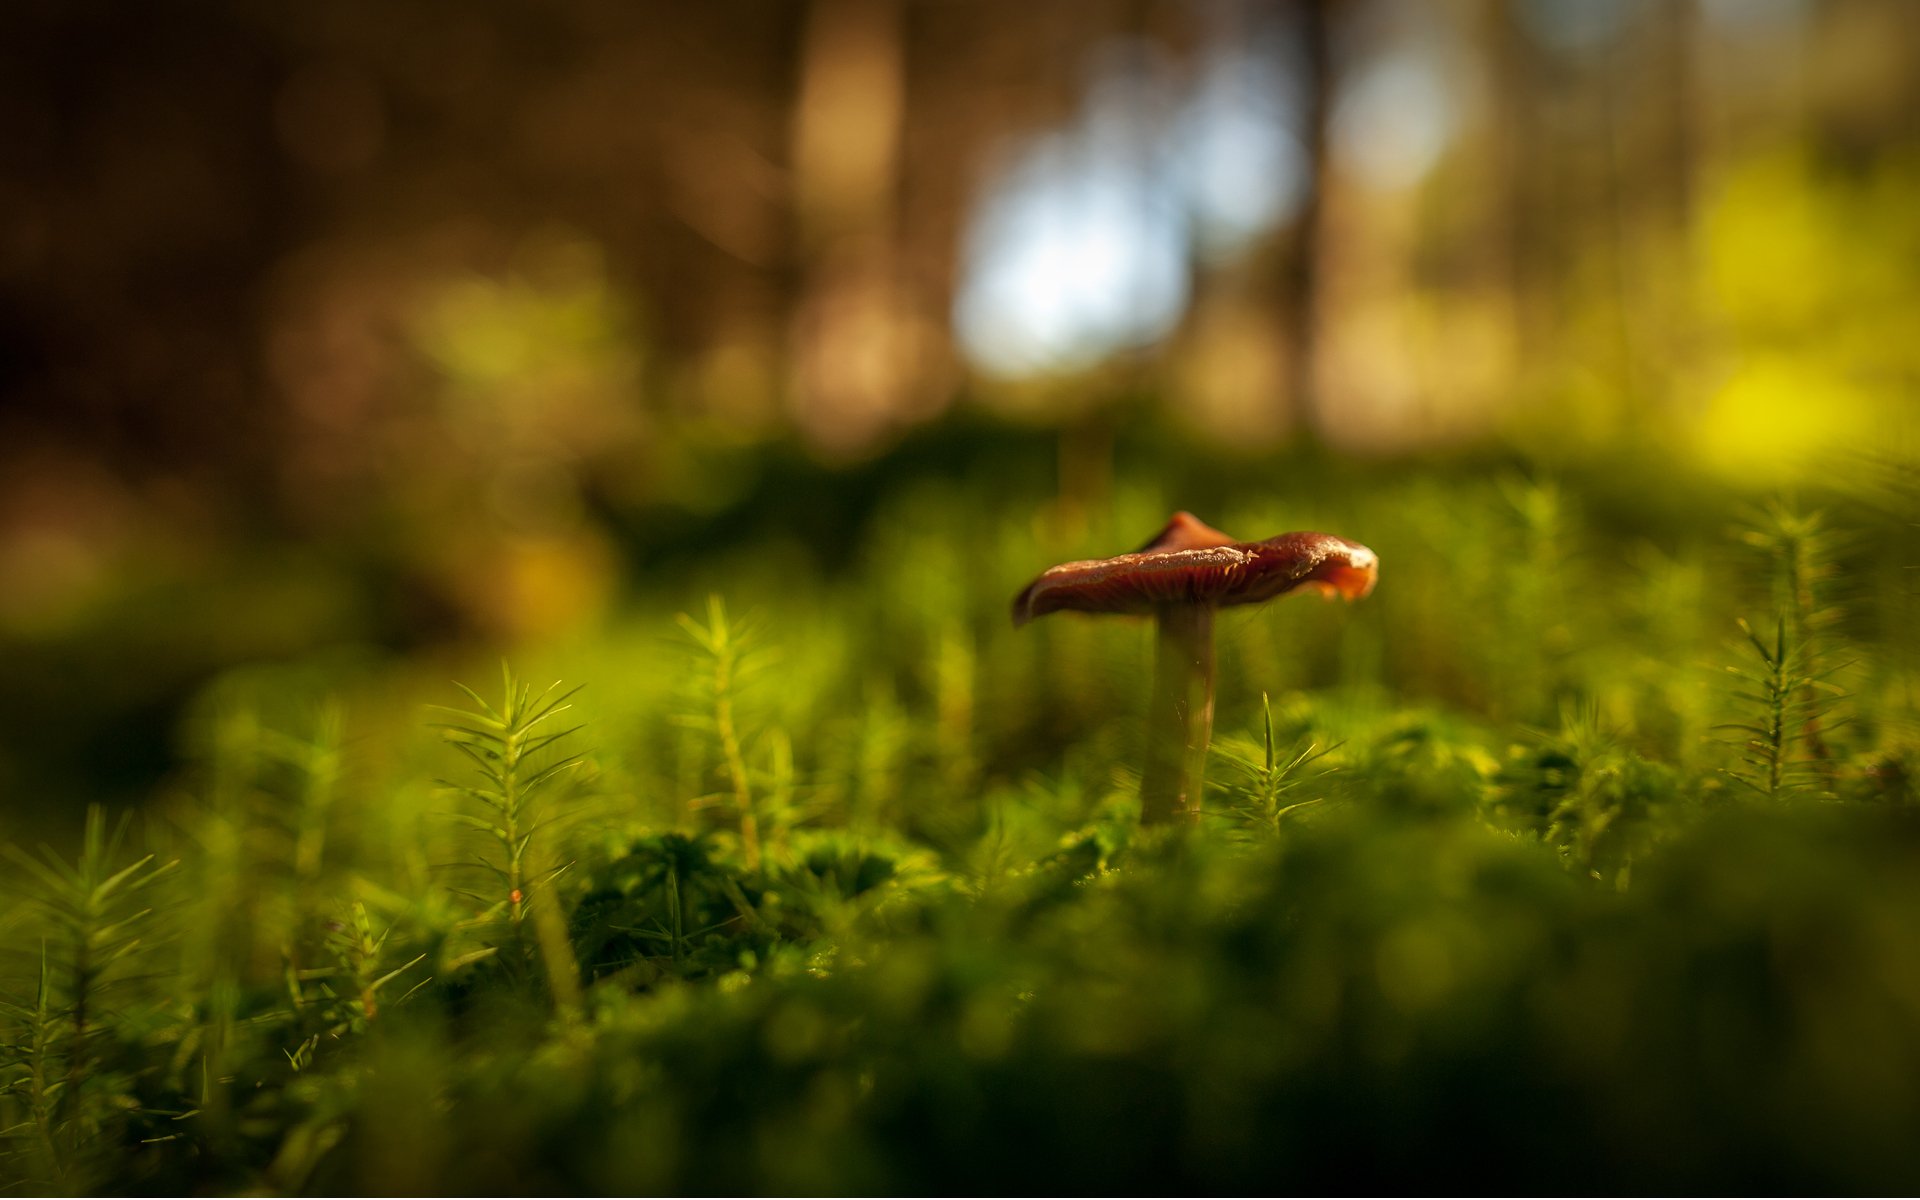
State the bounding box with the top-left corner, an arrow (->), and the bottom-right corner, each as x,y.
1140,603 -> 1213,826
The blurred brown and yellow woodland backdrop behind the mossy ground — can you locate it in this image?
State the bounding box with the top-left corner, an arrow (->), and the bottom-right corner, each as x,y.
0,0 -> 1920,831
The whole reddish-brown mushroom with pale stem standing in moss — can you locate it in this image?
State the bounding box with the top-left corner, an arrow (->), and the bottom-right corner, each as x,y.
1014,513 -> 1379,826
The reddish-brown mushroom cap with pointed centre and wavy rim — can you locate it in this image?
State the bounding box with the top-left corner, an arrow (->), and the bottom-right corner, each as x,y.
1014,513 -> 1380,626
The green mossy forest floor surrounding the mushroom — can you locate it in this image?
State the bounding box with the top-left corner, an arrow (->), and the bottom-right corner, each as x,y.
0,453 -> 1920,1194
